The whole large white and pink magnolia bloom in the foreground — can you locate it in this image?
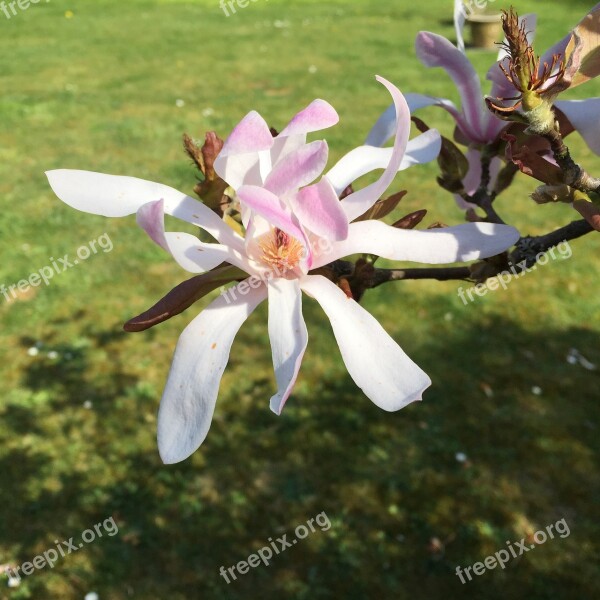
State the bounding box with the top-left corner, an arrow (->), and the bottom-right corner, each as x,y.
48,79 -> 519,463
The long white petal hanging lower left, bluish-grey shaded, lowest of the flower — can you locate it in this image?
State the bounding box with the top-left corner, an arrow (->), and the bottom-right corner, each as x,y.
158,282 -> 267,464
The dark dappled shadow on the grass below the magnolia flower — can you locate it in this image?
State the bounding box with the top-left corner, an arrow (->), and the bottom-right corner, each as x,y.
0,319 -> 600,600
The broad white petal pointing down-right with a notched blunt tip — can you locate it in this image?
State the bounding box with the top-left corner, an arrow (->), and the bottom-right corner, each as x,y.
300,275 -> 431,411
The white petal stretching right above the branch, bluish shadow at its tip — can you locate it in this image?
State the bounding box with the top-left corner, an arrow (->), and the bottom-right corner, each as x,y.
313,220 -> 519,269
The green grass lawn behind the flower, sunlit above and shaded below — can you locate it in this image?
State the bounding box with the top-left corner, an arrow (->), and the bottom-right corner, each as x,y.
0,0 -> 600,600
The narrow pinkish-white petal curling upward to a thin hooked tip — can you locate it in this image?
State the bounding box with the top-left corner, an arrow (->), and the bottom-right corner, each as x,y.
342,76 -> 410,221
